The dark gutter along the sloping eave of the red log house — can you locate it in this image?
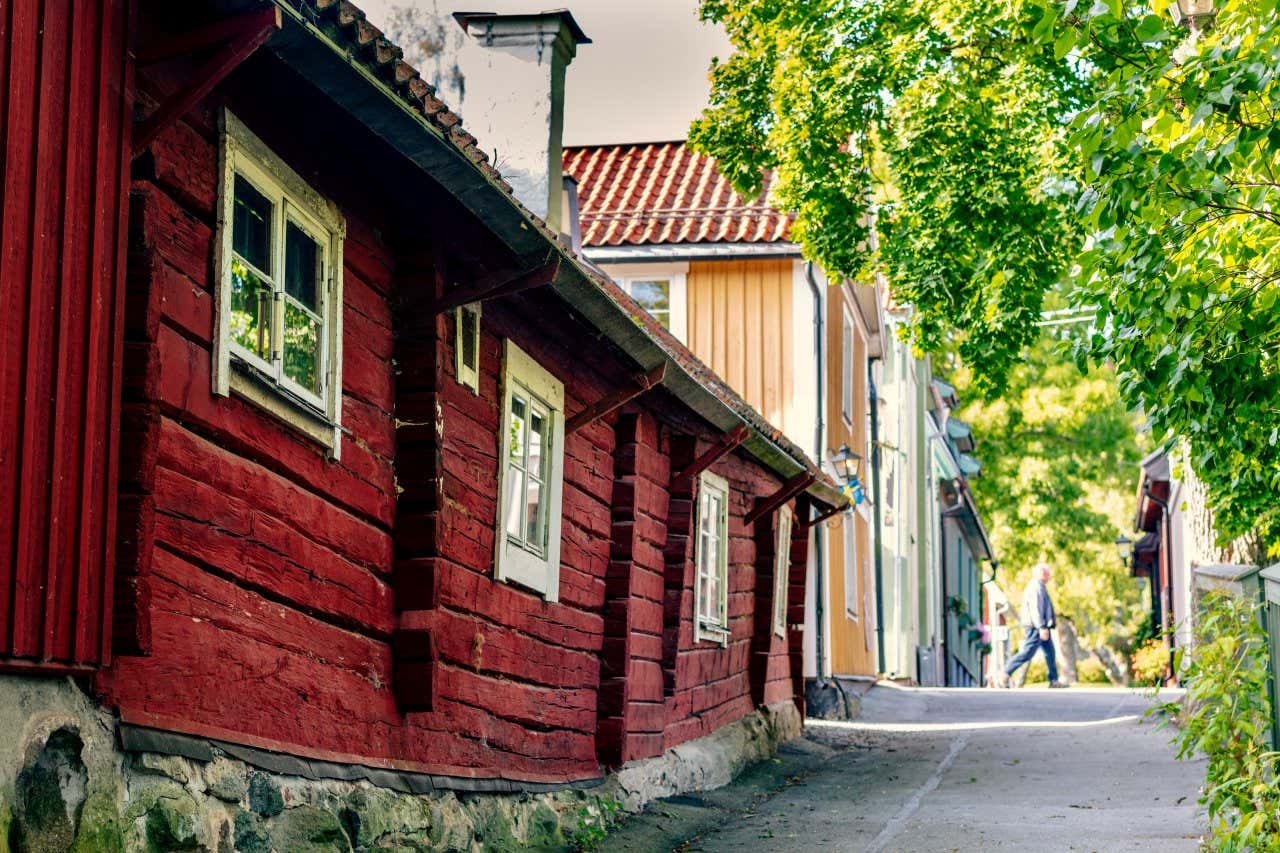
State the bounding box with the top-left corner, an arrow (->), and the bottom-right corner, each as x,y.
263,0 -> 846,506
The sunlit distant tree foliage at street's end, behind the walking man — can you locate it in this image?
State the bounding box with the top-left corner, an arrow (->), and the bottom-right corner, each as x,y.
957,334 -> 1147,654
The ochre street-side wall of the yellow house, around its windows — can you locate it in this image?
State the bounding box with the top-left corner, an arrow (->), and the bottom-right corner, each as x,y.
826,286 -> 877,675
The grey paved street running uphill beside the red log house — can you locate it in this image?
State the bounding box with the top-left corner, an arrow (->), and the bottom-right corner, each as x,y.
605,686 -> 1202,853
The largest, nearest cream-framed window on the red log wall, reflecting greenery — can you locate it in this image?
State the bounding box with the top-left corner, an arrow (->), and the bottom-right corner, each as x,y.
214,110 -> 346,457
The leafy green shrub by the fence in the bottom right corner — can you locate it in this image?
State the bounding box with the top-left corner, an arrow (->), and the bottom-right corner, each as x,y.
1153,590 -> 1280,853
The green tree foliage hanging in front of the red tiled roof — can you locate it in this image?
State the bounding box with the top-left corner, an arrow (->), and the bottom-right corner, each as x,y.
690,0 -> 1084,388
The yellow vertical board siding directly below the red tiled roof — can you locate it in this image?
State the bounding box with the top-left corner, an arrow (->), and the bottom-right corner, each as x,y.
686,259 -> 808,434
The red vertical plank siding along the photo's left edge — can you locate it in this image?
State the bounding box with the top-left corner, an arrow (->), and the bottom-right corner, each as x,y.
0,0 -> 132,671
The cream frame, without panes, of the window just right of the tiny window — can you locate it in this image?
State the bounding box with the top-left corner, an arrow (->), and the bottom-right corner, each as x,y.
494,338 -> 564,602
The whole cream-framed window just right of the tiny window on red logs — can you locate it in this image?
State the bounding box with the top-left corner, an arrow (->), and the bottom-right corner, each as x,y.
494,341 -> 564,601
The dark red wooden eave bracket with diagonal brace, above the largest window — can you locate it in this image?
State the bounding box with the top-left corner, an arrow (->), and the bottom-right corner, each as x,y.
133,5 -> 283,158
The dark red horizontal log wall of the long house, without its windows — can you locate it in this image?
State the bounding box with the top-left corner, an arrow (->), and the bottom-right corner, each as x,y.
96,56 -> 803,781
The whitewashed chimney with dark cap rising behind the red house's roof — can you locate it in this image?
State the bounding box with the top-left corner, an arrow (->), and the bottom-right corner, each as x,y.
453,9 -> 591,232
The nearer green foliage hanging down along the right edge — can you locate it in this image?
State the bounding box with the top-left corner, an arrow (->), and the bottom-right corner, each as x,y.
1037,0 -> 1280,543
